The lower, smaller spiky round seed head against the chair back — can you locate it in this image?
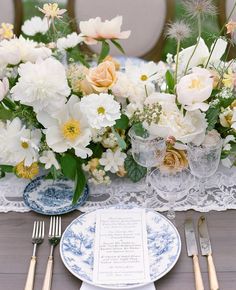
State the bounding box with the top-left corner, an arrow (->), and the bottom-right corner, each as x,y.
166,20 -> 191,42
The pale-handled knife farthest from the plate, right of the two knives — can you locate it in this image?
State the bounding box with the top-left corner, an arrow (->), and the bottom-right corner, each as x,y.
198,216 -> 219,290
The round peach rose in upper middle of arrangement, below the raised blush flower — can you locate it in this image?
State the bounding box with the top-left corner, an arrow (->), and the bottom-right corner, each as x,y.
86,61 -> 117,93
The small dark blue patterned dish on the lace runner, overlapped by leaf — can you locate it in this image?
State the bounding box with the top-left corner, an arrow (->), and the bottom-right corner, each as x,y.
23,176 -> 89,215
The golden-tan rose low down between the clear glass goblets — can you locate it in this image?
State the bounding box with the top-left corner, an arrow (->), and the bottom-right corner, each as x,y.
159,148 -> 188,173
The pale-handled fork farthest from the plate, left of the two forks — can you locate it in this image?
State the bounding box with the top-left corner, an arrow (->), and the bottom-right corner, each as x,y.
25,221 -> 44,290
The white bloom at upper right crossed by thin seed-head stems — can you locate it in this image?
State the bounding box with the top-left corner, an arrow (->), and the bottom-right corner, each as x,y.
178,38 -> 227,72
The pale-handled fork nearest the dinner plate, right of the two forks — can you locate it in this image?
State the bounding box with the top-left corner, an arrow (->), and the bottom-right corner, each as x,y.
42,216 -> 61,290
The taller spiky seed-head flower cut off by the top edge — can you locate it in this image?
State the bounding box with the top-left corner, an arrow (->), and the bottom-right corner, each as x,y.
183,0 -> 217,18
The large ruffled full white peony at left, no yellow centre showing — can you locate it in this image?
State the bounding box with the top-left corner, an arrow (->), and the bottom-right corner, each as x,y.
11,58 -> 70,113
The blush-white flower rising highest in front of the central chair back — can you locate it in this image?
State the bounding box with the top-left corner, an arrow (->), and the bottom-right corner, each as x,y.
79,16 -> 130,44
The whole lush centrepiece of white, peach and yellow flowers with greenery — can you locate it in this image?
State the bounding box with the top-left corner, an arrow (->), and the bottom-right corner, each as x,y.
0,0 -> 236,202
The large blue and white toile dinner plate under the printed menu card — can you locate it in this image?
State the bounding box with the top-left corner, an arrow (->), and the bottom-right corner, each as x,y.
60,207 -> 181,289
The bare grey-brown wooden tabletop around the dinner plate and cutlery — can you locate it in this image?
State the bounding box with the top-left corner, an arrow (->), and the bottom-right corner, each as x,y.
0,210 -> 236,290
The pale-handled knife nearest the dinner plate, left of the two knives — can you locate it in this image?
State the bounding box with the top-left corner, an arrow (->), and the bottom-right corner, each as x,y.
185,219 -> 204,290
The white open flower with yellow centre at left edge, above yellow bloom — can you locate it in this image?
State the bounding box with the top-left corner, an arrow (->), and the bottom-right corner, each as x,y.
0,118 -> 42,166
